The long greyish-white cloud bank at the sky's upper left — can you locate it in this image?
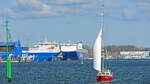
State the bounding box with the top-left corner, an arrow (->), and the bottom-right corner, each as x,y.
0,0 -> 87,18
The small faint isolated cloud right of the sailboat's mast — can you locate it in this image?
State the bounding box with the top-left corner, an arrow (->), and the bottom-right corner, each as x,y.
122,9 -> 138,20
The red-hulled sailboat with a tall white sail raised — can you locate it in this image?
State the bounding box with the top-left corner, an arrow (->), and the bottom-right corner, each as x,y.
93,3 -> 113,82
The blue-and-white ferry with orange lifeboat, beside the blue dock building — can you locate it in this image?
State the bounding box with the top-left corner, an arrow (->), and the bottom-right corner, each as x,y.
22,40 -> 60,61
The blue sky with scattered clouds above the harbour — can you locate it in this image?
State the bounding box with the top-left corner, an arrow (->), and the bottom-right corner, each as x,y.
0,0 -> 150,48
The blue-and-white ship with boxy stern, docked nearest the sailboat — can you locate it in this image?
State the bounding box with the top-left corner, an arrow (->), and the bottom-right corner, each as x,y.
60,42 -> 88,61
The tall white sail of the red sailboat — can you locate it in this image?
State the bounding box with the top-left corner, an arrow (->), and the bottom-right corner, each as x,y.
93,28 -> 102,71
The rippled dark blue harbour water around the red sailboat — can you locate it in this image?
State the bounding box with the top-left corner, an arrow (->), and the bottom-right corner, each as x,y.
0,60 -> 150,84
